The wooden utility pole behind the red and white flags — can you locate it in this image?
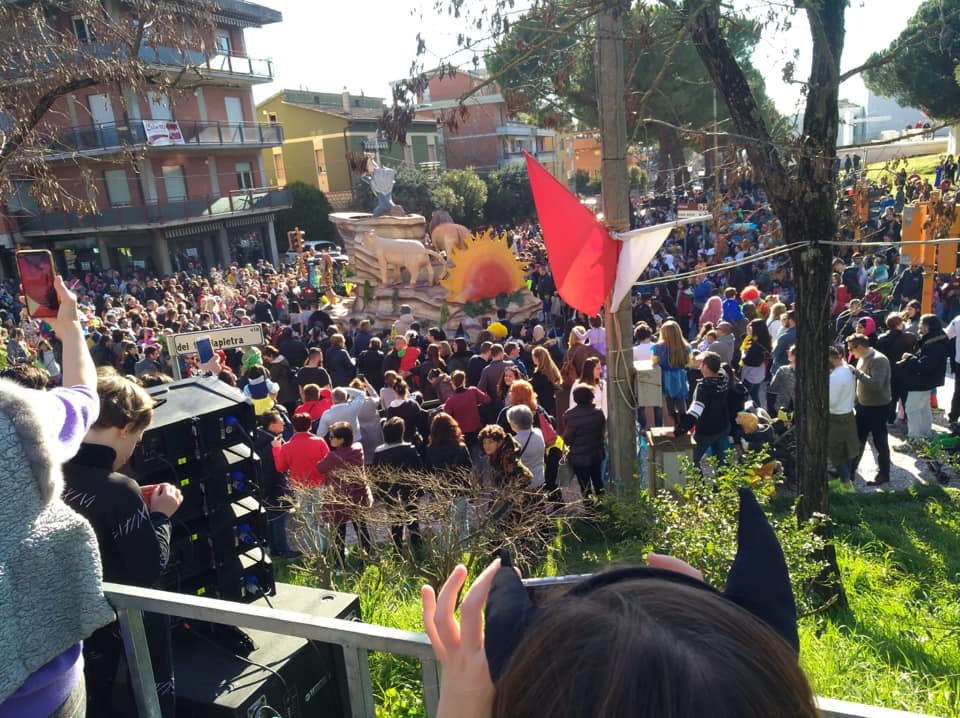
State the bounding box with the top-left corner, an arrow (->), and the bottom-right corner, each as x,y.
597,5 -> 639,495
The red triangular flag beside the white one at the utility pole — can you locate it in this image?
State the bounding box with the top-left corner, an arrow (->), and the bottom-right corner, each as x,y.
523,151 -> 620,316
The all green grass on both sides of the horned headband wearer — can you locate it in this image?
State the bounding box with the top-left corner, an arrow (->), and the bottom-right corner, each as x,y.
278,487 -> 960,718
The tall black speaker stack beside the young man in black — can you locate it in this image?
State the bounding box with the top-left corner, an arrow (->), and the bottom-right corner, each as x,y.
130,377 -> 275,601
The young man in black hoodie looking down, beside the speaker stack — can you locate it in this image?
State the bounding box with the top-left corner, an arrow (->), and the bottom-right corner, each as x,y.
63,373 -> 183,718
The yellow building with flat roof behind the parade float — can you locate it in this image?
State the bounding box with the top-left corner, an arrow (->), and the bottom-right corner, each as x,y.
257,90 -> 440,209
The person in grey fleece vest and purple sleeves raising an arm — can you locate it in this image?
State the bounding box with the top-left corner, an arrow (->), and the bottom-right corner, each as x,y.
0,277 -> 113,717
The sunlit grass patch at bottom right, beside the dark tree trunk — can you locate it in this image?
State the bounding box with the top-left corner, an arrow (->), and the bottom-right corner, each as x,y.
801,487 -> 960,716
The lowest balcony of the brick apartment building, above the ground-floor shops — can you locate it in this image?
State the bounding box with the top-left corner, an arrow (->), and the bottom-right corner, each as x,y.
15,187 -> 291,237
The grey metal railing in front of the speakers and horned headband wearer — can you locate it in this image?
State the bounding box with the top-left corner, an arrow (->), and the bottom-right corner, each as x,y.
103,577 -> 932,718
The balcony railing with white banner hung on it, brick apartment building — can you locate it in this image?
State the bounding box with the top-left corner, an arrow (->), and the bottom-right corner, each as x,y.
47,120 -> 283,155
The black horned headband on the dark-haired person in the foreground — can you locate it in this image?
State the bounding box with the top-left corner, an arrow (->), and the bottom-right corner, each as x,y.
484,489 -> 800,681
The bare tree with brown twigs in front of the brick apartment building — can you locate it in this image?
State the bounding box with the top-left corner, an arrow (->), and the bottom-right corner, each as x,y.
0,0 -> 215,212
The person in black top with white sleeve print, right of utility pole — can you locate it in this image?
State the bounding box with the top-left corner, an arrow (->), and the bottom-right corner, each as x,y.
674,352 -> 730,466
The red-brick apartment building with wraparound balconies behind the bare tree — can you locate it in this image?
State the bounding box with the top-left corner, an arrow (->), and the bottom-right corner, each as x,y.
0,0 -> 290,274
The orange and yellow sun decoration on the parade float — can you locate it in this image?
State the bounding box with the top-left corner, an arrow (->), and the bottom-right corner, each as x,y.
440,229 -> 526,304
